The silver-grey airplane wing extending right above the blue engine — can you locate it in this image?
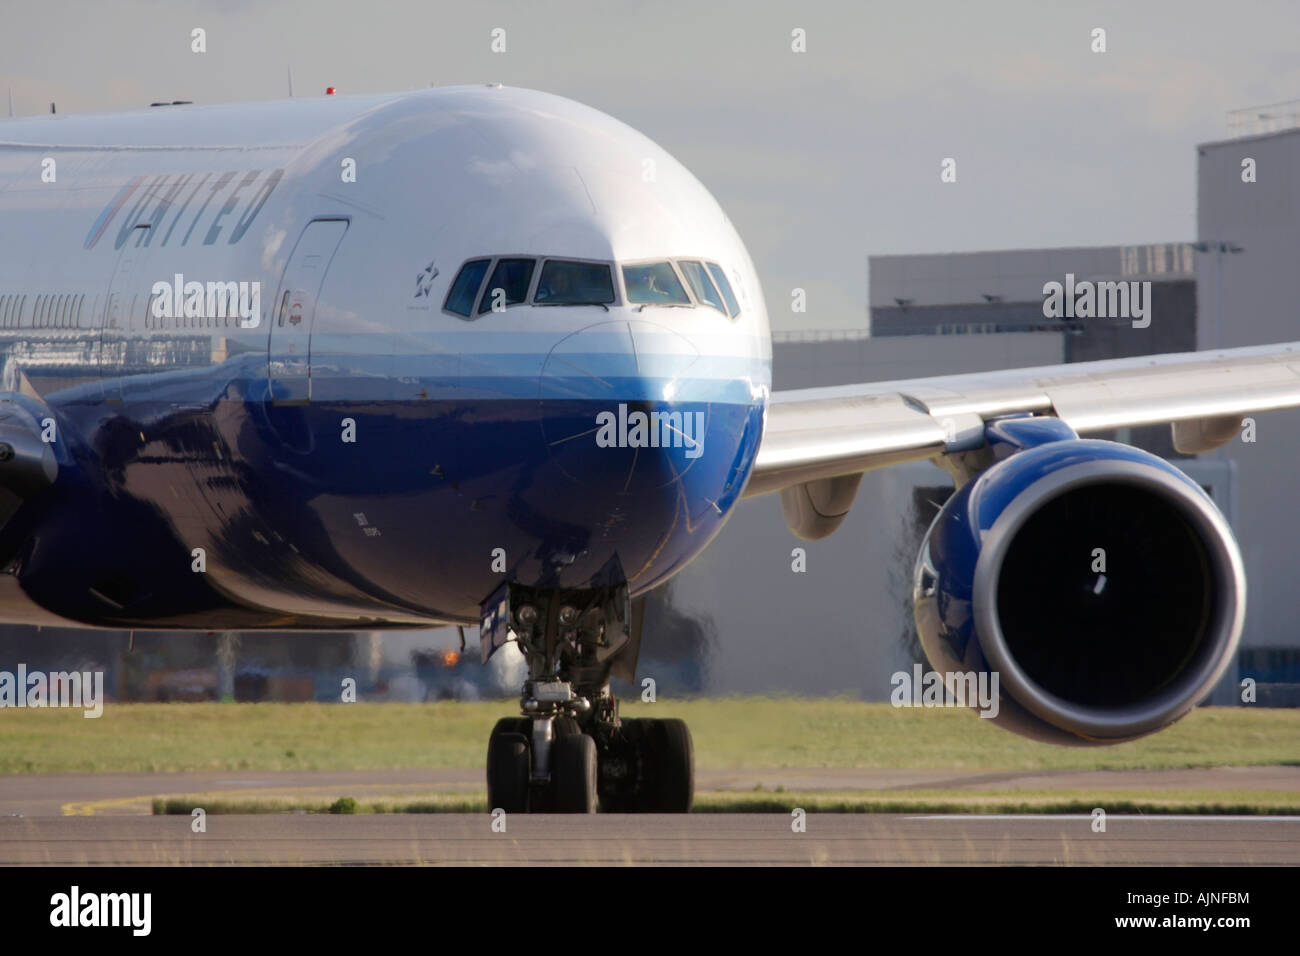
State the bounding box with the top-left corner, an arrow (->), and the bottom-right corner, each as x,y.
745,342 -> 1300,537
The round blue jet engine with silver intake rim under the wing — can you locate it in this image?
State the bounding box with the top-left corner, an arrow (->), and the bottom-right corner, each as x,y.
913,418 -> 1245,744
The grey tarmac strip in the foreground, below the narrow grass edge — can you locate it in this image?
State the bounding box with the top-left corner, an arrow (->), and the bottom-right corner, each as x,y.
0,813 -> 1300,866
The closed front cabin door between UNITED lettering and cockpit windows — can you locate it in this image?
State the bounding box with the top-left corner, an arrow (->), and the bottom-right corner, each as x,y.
267,219 -> 347,405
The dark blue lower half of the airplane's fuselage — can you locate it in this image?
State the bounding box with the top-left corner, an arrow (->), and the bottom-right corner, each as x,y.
0,354 -> 764,628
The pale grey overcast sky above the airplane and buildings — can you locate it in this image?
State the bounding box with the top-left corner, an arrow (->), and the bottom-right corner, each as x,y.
0,0 -> 1300,328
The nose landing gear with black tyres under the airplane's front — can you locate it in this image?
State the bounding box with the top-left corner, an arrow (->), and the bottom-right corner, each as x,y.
482,584 -> 694,813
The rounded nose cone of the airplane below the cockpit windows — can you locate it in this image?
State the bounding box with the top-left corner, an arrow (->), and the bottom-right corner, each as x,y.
540,319 -> 707,496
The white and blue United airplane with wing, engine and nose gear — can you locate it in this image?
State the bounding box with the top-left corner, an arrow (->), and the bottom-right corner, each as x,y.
0,85 -> 1300,813
